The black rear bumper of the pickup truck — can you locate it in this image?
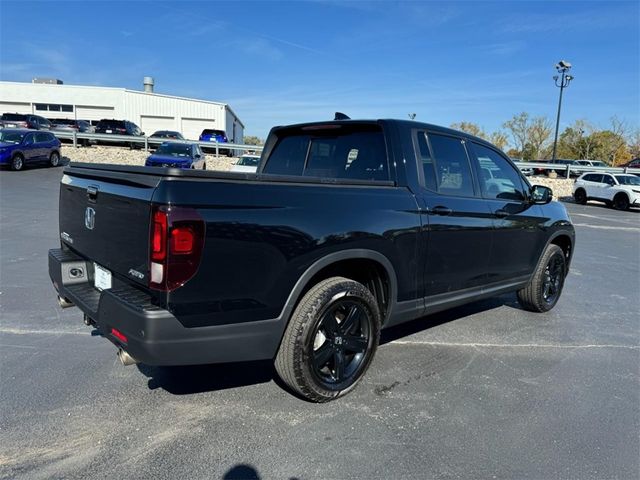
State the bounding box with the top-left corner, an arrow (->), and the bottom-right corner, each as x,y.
49,249 -> 284,365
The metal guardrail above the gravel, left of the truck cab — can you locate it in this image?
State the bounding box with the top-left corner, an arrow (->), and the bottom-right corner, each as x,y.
51,130 -> 264,157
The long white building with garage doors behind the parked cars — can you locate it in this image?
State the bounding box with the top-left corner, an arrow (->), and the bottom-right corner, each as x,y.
0,77 -> 244,143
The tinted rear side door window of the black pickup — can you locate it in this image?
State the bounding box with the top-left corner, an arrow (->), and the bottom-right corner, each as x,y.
429,133 -> 475,197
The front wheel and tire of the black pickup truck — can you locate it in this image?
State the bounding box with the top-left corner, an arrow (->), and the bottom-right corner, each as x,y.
518,245 -> 567,312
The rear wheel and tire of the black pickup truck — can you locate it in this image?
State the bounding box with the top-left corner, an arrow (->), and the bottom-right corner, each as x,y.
275,277 -> 380,402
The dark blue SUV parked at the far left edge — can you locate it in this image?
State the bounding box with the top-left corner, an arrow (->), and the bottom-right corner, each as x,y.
0,128 -> 60,170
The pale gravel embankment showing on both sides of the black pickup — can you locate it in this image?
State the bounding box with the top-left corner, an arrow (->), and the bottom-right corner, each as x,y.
62,145 -> 573,199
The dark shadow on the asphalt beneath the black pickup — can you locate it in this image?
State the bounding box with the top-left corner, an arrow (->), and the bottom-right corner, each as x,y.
137,294 -> 520,395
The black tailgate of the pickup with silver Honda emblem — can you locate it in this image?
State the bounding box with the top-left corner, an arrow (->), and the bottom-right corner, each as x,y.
60,168 -> 161,286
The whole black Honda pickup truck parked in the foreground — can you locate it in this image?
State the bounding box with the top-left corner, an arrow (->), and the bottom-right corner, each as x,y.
49,120 -> 574,402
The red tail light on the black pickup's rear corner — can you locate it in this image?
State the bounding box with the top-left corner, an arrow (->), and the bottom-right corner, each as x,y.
149,207 -> 205,292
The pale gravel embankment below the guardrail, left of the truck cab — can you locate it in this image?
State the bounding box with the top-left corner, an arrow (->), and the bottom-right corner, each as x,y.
62,144 -> 238,170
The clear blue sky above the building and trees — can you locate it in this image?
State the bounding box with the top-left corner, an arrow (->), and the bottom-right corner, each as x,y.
0,0 -> 640,141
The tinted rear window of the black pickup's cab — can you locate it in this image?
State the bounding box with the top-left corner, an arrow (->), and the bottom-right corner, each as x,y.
264,125 -> 389,180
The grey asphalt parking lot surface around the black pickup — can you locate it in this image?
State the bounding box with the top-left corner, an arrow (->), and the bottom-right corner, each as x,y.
0,168 -> 640,479
